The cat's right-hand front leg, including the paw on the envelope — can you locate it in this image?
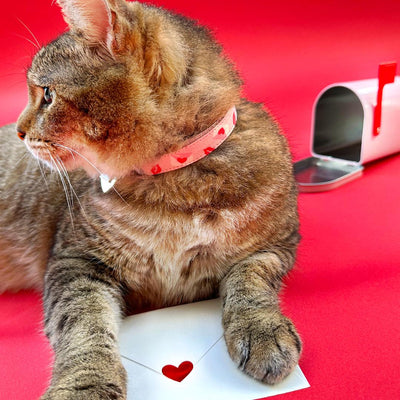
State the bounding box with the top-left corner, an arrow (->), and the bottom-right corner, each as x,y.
221,248 -> 302,384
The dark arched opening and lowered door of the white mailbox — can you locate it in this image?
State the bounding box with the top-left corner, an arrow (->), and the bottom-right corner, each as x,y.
295,86 -> 364,192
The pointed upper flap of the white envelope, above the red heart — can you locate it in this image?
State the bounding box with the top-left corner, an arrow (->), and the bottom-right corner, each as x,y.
119,299 -> 223,373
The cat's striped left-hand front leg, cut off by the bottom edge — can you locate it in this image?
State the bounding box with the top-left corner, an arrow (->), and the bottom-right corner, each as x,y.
42,258 -> 126,400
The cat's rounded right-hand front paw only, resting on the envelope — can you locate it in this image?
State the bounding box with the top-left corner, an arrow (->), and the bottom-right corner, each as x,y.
224,309 -> 302,384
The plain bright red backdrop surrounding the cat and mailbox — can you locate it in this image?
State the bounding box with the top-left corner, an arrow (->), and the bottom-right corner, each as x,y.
0,0 -> 400,400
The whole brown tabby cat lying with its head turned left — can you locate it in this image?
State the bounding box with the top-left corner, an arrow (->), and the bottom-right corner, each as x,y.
0,0 -> 301,400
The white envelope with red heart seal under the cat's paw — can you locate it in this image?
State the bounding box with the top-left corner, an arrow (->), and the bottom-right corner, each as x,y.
119,299 -> 309,400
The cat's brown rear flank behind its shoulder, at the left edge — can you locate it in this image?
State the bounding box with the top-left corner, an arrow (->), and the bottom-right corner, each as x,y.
0,124 -> 63,293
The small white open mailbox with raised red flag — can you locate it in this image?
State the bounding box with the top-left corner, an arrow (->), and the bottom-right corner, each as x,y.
294,63 -> 400,192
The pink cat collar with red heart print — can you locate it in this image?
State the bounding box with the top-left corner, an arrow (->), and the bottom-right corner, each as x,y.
140,106 -> 237,175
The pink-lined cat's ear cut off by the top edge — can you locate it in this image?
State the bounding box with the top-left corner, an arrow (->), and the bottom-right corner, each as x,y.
57,0 -> 125,50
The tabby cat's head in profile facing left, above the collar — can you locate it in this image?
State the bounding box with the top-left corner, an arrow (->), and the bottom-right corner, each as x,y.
17,0 -> 240,177
